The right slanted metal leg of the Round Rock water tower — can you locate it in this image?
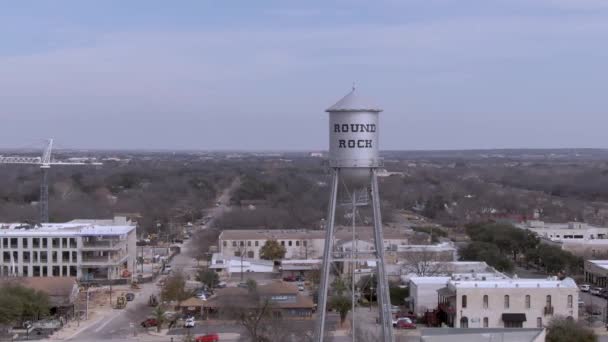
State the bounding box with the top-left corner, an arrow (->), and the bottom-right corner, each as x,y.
372,169 -> 394,342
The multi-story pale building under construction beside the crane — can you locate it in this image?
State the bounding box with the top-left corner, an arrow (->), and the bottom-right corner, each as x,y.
0,223 -> 137,281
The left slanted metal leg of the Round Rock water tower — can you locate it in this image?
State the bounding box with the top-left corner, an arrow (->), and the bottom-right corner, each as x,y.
314,169 -> 340,342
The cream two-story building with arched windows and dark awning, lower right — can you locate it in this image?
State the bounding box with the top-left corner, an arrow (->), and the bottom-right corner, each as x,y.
437,277 -> 578,328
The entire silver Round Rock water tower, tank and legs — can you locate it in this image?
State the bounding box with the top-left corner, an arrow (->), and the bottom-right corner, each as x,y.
315,87 -> 393,342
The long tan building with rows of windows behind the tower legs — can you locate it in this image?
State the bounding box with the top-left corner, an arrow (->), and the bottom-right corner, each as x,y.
219,227 -> 408,259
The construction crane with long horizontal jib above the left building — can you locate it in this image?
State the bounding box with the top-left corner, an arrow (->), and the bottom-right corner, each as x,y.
0,139 -> 103,223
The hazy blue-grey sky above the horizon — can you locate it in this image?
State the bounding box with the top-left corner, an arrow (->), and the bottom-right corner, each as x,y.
0,0 -> 608,150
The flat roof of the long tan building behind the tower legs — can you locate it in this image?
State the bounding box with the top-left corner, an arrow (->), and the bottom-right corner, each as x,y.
220,227 -> 408,241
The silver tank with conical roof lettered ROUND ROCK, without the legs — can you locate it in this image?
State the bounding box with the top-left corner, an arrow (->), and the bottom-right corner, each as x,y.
326,88 -> 382,188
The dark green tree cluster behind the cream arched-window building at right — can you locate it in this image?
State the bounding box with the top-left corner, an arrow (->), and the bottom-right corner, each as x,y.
460,223 -> 583,275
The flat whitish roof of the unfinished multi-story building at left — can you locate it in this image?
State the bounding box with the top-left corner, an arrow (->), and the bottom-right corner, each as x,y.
0,223 -> 135,237
